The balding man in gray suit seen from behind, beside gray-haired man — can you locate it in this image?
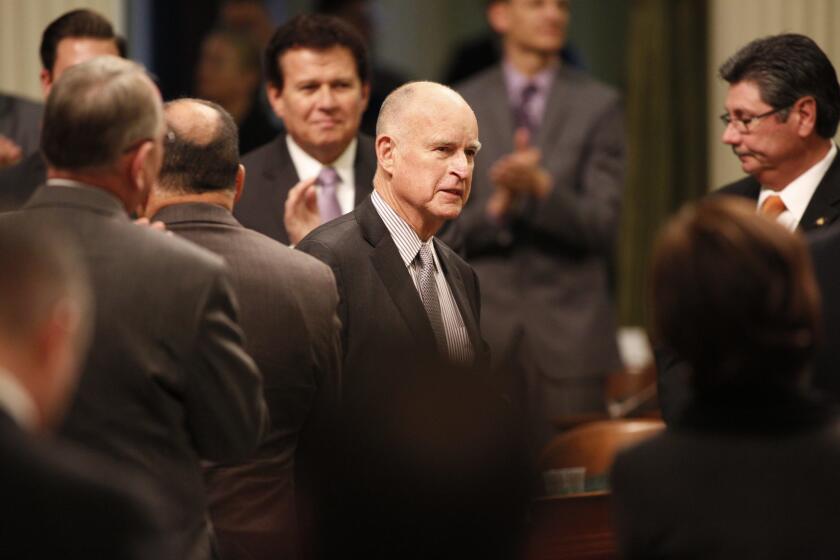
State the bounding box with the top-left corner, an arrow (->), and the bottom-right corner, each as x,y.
146,99 -> 340,560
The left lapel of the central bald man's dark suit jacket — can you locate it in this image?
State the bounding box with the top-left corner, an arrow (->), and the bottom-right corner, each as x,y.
355,197 -> 436,348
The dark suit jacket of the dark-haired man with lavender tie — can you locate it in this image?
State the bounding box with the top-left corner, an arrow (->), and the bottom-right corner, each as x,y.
233,134 -> 376,244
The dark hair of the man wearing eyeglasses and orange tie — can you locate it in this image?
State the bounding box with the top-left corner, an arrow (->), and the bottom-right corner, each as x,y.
719,33 -> 840,138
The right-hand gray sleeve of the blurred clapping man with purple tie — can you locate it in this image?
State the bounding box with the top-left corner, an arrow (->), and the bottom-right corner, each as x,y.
519,96 -> 626,253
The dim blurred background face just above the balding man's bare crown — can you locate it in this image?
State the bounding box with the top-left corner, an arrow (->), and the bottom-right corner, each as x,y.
196,36 -> 260,108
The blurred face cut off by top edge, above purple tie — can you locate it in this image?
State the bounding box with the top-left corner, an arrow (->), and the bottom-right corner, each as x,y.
490,0 -> 569,54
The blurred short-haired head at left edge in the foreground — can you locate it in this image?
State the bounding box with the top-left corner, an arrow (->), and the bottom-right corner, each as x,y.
0,222 -> 91,429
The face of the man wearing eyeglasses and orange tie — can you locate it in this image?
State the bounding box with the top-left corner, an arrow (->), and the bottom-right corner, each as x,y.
721,81 -> 802,186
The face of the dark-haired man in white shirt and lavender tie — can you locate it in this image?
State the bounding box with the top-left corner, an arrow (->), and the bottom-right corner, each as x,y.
268,47 -> 370,164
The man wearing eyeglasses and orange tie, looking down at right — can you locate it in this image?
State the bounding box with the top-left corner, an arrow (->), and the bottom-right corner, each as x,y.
720,34 -> 840,231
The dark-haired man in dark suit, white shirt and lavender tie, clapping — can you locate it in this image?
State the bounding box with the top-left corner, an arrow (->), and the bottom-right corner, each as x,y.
235,14 -> 376,245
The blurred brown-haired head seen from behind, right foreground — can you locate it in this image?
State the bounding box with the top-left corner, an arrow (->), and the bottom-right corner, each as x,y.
651,196 -> 819,396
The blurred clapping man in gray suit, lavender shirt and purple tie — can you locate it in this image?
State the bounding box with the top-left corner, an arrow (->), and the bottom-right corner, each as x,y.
447,0 -> 625,444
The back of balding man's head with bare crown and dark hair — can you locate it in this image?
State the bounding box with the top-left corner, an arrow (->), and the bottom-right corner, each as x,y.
158,99 -> 239,194
